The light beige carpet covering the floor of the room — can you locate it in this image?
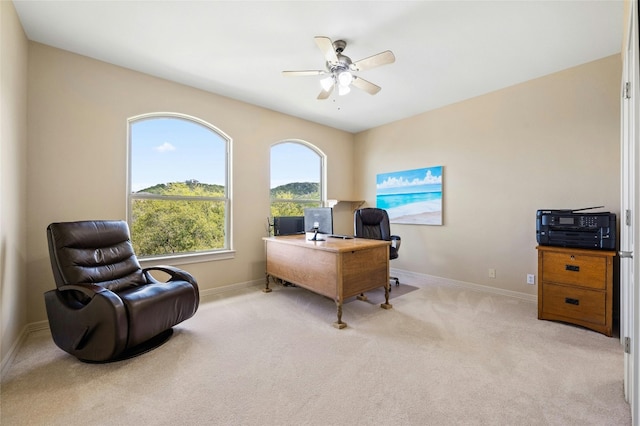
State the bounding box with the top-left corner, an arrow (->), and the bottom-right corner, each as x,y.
0,285 -> 630,425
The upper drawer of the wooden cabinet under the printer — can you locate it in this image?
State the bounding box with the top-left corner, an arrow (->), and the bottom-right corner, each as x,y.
541,252 -> 607,289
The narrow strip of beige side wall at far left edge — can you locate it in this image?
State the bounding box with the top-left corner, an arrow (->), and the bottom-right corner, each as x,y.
0,1 -> 28,367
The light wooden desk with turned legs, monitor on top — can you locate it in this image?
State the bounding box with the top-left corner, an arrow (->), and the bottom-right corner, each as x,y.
263,235 -> 392,328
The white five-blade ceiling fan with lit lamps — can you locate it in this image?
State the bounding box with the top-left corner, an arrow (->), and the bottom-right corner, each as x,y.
282,36 -> 396,99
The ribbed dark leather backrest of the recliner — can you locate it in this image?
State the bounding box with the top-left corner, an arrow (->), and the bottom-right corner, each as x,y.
47,220 -> 146,292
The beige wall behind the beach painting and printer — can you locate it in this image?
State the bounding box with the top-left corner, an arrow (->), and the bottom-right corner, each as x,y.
354,55 -> 621,295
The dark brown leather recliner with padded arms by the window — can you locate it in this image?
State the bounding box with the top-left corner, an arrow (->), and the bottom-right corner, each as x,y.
44,221 -> 200,362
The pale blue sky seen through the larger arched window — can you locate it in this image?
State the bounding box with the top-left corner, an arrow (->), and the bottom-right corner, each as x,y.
131,118 -> 226,192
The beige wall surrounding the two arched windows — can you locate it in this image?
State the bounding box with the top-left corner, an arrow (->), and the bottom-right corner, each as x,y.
27,43 -> 353,322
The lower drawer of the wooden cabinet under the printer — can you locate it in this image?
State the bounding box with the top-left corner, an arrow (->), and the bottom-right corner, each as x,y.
542,283 -> 607,324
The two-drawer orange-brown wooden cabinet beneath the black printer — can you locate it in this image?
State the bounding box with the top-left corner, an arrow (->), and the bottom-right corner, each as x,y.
537,246 -> 616,336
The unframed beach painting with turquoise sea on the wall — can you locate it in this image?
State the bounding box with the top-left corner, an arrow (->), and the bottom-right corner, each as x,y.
376,166 -> 442,225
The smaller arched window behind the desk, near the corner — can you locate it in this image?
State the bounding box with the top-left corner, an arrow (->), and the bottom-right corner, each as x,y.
270,141 -> 326,217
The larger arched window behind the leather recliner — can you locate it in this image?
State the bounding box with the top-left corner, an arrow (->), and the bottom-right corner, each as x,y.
128,113 -> 231,258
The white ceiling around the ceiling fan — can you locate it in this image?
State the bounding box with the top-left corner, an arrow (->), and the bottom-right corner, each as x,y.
14,0 -> 623,132
